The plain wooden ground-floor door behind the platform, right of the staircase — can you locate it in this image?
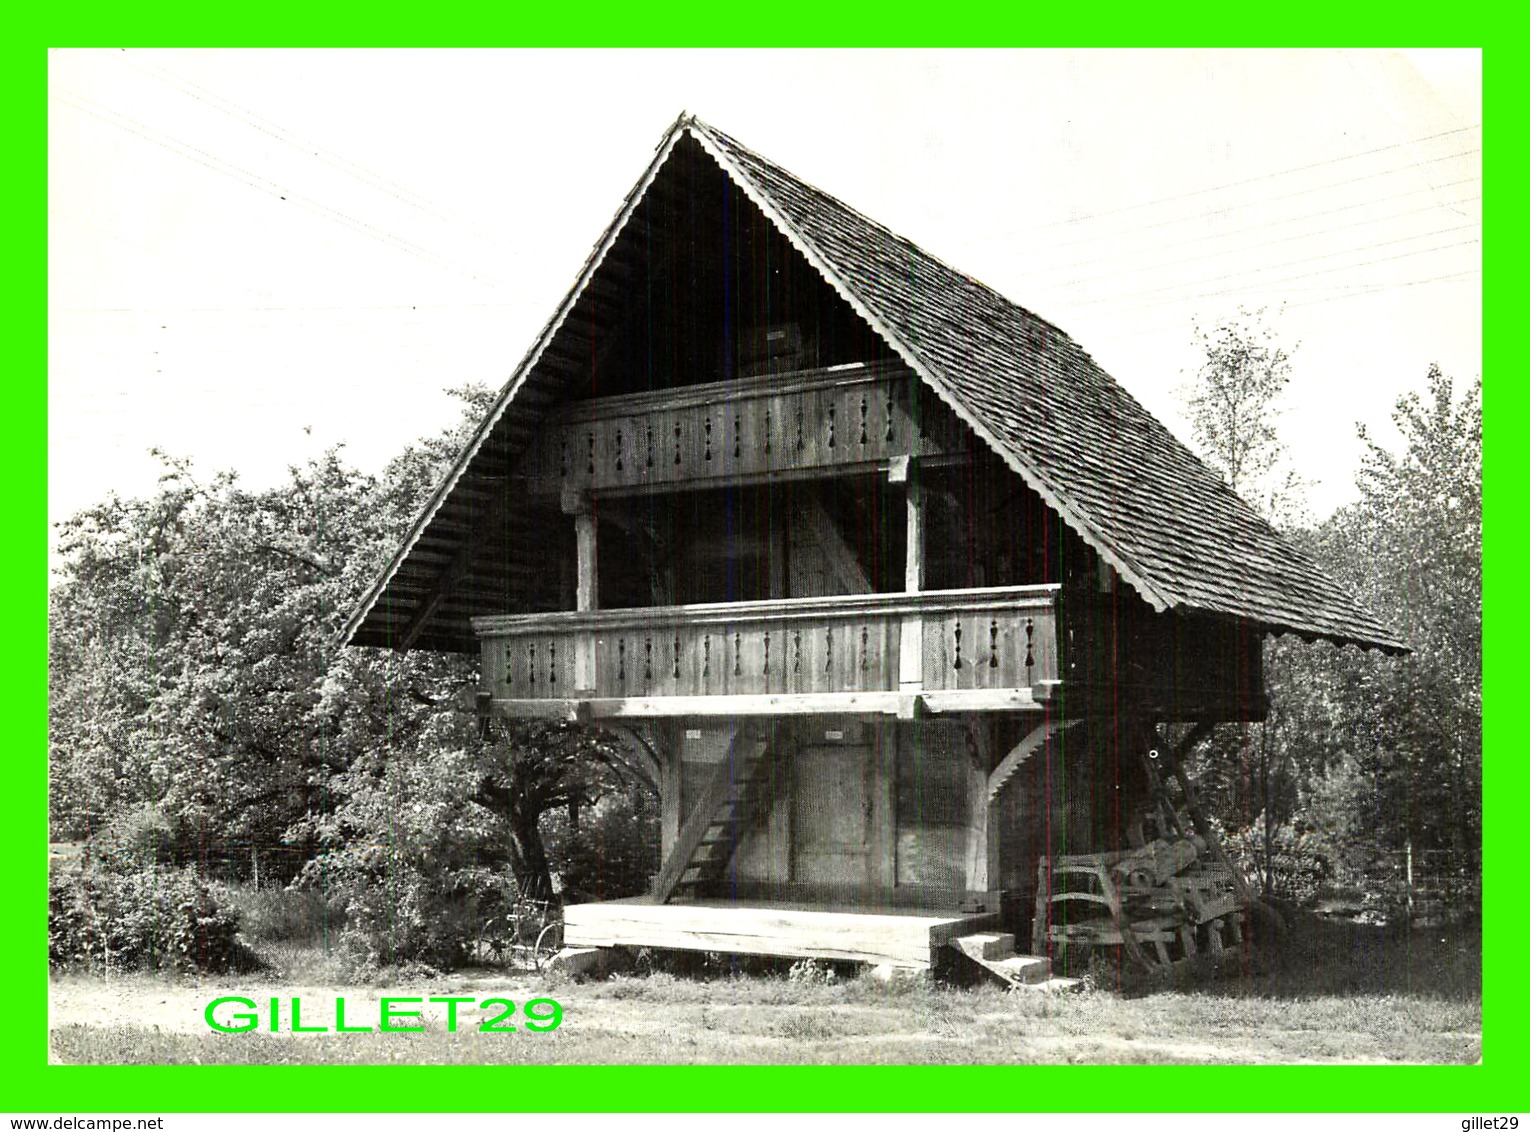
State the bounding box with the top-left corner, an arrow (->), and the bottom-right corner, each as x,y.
793,745 -> 874,887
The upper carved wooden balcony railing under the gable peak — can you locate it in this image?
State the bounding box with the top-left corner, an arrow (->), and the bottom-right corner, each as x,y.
528,363 -> 959,494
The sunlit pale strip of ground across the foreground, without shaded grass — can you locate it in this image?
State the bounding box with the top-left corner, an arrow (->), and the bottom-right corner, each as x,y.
50,971 -> 1481,1065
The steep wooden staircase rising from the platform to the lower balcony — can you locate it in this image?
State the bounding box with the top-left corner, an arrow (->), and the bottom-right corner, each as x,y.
653,728 -> 773,904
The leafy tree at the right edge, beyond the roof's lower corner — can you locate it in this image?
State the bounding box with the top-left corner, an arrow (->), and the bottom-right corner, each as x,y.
1319,366 -> 1483,867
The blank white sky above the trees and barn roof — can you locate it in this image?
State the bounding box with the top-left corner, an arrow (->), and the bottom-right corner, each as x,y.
49,50 -> 1481,544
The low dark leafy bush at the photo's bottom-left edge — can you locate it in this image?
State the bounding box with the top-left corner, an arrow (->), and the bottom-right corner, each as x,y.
47,866 -> 242,971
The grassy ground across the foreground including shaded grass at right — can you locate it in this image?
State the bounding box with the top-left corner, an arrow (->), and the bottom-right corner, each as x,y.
52,919 -> 1481,1065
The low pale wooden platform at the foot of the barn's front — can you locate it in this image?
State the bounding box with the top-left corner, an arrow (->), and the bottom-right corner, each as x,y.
563,901 -> 999,968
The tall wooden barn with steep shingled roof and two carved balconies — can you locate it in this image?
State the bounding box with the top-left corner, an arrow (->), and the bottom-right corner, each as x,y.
349,116 -> 1401,979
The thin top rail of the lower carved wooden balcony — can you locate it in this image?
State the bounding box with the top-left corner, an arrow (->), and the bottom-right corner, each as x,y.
473,584 -> 1060,636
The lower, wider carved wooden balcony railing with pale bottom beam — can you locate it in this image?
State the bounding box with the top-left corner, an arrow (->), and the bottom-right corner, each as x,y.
473,586 -> 1060,717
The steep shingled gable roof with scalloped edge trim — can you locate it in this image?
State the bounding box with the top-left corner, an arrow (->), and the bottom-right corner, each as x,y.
346,116 -> 1405,650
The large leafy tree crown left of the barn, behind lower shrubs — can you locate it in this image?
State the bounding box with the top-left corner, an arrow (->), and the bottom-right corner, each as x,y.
49,390 -> 482,870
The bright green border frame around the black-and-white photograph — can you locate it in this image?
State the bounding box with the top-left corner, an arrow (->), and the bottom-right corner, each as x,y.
11,22 -> 1511,1114
